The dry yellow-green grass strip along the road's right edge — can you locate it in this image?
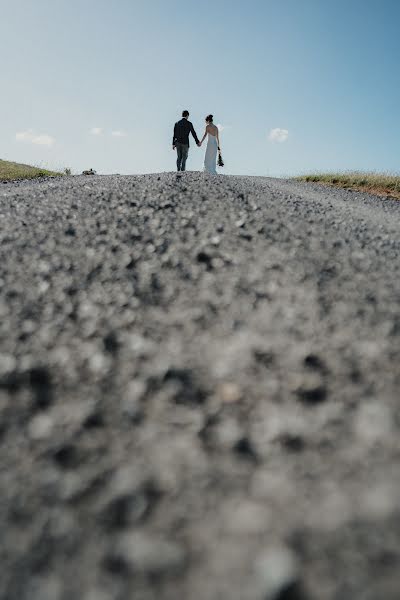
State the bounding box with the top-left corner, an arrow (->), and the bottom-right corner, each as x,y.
295,171 -> 400,199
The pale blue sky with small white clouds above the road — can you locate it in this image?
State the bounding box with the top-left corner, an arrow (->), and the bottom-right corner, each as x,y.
0,0 -> 400,176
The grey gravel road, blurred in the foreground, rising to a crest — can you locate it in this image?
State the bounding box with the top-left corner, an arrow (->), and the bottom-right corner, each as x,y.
0,173 -> 400,600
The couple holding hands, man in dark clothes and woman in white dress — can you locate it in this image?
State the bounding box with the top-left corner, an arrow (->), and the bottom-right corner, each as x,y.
172,110 -> 223,175
